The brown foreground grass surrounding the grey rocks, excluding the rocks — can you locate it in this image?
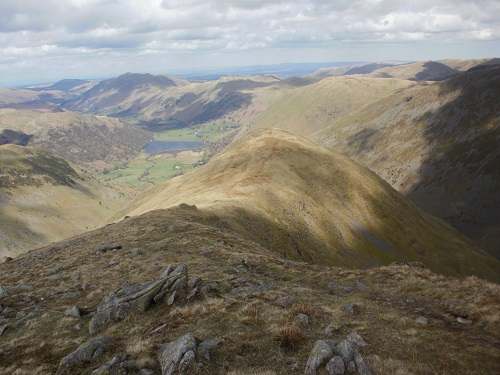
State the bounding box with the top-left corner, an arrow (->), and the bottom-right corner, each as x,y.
0,207 -> 500,375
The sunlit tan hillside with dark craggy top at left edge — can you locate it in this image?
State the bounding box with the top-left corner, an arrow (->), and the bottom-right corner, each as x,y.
0,145 -> 127,259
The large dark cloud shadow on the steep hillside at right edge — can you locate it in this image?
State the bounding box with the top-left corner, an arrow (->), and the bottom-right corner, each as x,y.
405,68 -> 500,258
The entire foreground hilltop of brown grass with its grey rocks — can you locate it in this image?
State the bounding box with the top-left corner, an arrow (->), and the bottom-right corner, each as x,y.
0,206 -> 500,374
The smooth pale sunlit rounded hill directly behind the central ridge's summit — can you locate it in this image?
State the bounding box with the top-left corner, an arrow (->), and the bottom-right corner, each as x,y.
246,76 -> 413,135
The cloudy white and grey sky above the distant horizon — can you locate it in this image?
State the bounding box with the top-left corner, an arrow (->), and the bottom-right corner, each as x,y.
0,0 -> 500,86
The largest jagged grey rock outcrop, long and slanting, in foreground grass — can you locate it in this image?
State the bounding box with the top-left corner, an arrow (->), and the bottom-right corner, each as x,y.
89,264 -> 202,334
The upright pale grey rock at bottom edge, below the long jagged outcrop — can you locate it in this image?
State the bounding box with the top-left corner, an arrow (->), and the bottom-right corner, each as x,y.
159,333 -> 196,375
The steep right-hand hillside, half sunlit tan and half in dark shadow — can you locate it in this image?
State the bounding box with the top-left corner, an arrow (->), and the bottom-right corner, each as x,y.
311,68 -> 500,256
